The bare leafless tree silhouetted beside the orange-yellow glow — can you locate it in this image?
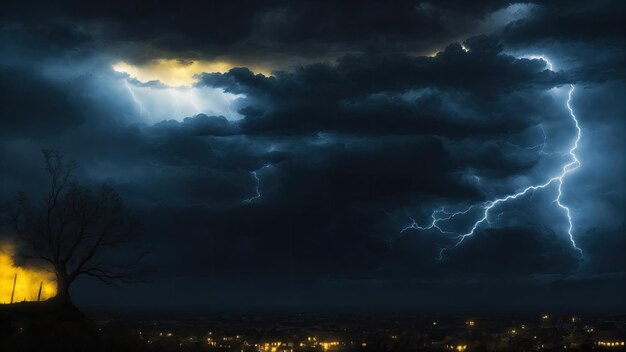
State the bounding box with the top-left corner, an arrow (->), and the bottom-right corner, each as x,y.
10,150 -> 141,306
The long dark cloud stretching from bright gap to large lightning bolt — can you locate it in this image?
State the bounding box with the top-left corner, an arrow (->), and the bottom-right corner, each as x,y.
199,36 -> 562,99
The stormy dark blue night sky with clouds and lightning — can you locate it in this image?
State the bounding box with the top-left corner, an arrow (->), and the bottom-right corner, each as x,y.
0,0 -> 626,311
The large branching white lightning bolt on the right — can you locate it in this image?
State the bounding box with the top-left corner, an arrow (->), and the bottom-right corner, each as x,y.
400,56 -> 582,260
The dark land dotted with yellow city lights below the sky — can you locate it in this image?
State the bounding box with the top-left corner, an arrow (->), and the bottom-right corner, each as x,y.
0,303 -> 626,352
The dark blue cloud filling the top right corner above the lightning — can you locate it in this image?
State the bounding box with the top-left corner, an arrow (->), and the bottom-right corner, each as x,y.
498,0 -> 626,83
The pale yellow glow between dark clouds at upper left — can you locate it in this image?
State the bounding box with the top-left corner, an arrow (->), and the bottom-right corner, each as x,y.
113,59 -> 267,87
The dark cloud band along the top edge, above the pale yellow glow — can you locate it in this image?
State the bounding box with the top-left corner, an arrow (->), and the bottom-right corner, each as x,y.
2,0 -> 508,67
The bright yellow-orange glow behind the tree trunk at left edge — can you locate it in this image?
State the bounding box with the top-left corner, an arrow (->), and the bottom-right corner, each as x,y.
0,244 -> 57,304
